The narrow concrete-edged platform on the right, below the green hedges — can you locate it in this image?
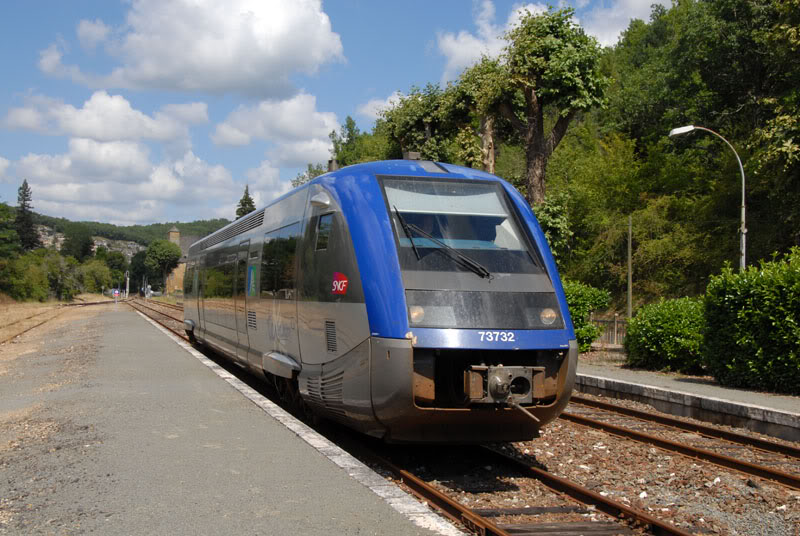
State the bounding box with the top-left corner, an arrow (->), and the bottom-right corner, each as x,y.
575,363 -> 800,441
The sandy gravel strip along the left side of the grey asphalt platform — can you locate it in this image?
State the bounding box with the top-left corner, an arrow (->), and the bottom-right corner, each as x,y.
0,309 -> 102,534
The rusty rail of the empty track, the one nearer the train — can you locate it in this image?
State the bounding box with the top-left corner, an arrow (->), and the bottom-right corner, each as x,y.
561,411 -> 800,490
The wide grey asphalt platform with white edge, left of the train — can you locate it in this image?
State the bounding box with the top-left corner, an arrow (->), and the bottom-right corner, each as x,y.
0,304 -> 461,536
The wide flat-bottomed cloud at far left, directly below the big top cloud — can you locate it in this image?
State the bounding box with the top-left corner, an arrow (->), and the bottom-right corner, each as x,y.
4,91 -> 208,141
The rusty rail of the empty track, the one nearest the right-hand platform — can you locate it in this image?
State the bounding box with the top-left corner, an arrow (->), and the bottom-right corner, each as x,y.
570,395 -> 800,459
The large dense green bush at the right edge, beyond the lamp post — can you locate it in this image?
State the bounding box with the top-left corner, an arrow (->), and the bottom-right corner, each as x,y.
703,247 -> 800,395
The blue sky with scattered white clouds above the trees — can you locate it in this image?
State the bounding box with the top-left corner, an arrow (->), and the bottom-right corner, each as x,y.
0,0 -> 663,225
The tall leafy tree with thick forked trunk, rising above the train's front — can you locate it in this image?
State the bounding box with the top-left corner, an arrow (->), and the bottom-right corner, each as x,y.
500,9 -> 606,205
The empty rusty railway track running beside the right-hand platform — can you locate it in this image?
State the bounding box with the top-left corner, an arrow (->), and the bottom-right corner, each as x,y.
560,396 -> 800,490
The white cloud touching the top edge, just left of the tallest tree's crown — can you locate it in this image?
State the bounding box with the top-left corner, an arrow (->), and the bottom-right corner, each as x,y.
437,0 -> 547,83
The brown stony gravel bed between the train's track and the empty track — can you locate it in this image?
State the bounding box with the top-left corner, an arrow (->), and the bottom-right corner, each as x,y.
506,412 -> 800,536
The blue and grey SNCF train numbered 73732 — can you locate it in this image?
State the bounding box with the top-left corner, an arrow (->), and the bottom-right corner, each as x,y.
183,160 -> 578,443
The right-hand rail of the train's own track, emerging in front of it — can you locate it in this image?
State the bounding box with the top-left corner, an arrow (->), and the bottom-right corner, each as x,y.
485,447 -> 692,536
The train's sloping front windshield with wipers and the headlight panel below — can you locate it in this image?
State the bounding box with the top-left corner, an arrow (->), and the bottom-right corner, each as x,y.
381,177 -> 564,329
